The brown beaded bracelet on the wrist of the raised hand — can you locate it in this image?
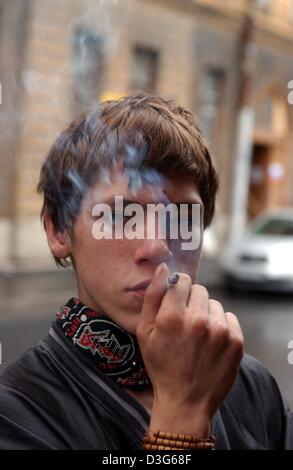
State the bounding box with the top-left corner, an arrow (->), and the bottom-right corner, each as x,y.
143,431 -> 215,450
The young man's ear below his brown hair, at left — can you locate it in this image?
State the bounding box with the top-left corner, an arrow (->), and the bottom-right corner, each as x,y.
44,211 -> 71,258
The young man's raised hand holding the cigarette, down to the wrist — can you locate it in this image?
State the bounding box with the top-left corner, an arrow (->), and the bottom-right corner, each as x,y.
137,263 -> 243,436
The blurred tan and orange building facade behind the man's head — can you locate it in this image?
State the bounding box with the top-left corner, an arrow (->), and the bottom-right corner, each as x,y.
0,0 -> 293,271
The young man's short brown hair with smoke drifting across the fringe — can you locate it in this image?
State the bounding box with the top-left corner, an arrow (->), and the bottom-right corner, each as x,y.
37,94 -> 218,266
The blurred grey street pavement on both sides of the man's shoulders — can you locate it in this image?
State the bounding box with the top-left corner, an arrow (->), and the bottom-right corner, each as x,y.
0,263 -> 293,409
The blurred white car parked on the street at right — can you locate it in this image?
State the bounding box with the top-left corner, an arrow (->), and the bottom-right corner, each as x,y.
220,209 -> 293,292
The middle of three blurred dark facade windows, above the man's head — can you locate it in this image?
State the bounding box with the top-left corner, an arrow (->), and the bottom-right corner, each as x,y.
131,46 -> 159,92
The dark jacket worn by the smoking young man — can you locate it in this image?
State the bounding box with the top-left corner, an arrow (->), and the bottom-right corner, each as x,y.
0,324 -> 293,450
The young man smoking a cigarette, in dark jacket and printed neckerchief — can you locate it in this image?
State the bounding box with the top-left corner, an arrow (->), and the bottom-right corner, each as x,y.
0,95 -> 293,449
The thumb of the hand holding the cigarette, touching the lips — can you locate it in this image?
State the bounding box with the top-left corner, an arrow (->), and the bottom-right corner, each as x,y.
140,263 -> 170,327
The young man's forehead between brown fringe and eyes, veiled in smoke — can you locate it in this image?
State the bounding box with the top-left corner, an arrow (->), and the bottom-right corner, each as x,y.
85,170 -> 202,204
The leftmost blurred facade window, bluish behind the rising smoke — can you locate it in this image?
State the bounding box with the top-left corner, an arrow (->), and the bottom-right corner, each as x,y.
73,29 -> 104,113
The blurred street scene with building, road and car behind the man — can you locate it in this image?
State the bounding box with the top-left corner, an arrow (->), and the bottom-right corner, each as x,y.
0,0 -> 293,408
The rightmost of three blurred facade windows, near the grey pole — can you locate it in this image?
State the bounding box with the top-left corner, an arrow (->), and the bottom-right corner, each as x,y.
200,67 -> 225,145
